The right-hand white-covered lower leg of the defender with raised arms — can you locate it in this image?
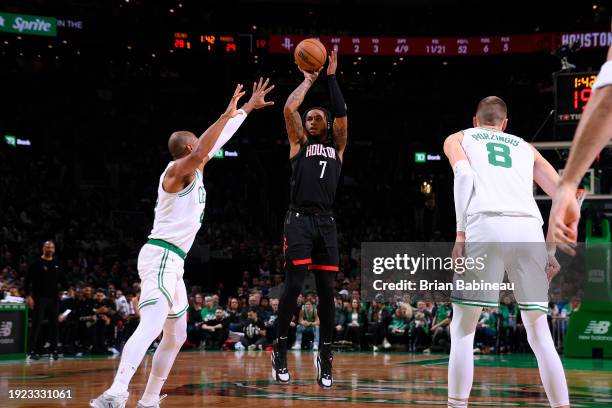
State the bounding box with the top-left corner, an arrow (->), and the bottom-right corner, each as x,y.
141,315 -> 187,405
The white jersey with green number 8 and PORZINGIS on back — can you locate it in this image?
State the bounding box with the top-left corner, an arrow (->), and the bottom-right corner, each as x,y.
461,128 -> 542,223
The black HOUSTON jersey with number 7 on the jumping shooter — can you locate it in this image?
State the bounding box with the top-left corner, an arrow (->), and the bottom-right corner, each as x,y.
289,139 -> 342,214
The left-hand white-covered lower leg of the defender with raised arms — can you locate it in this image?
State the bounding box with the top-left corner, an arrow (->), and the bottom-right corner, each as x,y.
108,299 -> 170,395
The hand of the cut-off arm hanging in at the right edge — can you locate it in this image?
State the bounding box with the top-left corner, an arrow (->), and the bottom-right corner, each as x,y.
548,183 -> 580,256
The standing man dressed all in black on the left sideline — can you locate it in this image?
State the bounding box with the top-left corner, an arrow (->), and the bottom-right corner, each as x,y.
24,241 -> 64,360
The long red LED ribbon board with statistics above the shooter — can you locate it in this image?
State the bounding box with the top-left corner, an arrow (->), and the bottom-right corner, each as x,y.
269,34 -> 551,56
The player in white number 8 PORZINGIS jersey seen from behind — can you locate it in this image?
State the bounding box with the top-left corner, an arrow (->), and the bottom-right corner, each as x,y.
444,96 -> 569,408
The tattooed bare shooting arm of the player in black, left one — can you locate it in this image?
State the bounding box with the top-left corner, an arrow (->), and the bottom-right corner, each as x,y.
283,67 -> 323,157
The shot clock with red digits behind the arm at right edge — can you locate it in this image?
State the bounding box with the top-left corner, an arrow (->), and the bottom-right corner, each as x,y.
555,72 -> 597,124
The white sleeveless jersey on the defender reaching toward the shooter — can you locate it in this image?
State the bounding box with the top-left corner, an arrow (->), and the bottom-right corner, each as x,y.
149,162 -> 206,253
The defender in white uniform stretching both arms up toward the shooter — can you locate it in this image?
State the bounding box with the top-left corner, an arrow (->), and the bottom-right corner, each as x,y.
90,78 -> 274,408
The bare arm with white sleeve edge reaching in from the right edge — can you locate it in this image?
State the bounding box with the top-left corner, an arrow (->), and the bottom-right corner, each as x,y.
548,47 -> 612,250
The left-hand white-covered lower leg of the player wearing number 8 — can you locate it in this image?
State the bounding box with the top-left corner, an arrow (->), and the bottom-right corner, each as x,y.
448,303 -> 482,407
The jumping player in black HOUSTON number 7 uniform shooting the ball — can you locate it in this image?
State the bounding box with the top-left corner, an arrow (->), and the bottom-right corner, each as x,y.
272,52 -> 348,388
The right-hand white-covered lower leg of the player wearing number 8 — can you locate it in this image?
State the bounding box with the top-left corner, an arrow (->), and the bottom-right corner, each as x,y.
521,310 -> 569,407
